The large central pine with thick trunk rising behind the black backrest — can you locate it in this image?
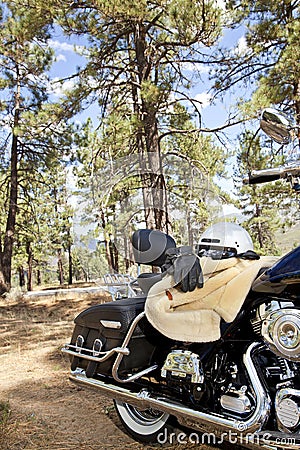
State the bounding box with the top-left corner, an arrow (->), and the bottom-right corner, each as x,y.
50,0 -> 220,231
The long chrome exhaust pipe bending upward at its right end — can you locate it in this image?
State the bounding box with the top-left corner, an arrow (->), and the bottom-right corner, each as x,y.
70,342 -> 272,436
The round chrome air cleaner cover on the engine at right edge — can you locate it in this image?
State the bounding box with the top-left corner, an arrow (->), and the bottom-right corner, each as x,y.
261,309 -> 300,361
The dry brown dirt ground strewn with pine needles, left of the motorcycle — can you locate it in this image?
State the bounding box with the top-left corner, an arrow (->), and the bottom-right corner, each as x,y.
0,295 -> 216,450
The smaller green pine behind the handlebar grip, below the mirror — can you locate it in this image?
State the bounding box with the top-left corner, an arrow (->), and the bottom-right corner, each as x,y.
235,131 -> 295,255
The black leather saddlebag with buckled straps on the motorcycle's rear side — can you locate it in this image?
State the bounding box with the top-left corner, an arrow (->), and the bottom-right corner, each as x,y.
71,297 -> 160,377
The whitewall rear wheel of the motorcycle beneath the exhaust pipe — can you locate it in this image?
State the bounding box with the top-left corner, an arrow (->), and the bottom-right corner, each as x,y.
114,400 -> 170,444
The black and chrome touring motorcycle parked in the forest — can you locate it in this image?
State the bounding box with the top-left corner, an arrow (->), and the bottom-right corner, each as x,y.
62,110 -> 300,449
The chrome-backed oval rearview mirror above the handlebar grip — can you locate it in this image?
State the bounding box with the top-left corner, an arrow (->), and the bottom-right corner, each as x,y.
260,108 -> 293,144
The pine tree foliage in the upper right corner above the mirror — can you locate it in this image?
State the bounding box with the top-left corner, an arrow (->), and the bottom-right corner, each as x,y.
214,0 -> 300,124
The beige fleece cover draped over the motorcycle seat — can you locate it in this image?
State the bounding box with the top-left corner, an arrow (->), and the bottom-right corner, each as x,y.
145,257 -> 278,342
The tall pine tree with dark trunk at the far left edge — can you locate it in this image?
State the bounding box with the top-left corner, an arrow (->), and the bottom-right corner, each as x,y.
0,1 -> 77,292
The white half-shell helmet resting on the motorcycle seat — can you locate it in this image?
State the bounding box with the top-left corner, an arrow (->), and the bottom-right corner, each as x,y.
199,222 -> 253,258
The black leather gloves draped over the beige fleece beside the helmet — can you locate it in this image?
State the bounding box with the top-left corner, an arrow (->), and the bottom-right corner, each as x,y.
162,246 -> 203,292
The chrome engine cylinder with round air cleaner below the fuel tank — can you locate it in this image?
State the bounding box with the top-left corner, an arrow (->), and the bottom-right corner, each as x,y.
252,300 -> 300,362
